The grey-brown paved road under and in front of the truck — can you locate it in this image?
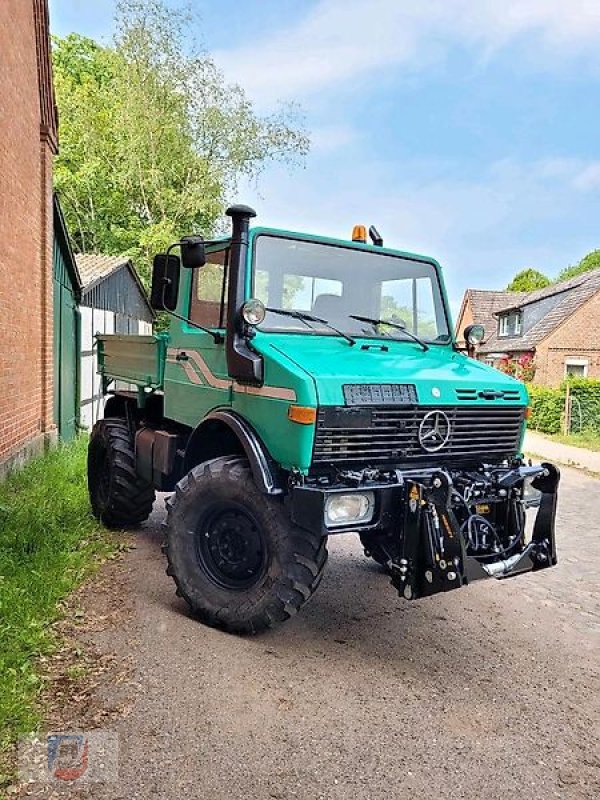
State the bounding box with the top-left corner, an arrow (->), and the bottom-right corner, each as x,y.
34,470 -> 600,800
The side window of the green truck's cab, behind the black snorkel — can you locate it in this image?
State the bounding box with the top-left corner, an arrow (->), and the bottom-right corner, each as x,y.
190,249 -> 229,328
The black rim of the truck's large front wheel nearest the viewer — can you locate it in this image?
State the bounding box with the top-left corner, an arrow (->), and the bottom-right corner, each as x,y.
196,503 -> 267,590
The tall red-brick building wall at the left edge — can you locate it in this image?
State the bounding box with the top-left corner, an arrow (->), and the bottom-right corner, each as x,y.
0,0 -> 57,472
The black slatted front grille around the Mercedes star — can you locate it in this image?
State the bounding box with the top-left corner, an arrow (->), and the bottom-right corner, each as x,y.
313,406 -> 525,466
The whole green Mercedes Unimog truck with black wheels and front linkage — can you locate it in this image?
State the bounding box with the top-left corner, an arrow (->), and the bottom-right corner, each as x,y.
88,206 -> 559,633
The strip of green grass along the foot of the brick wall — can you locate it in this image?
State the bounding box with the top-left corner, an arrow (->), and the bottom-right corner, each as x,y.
0,437 -> 118,793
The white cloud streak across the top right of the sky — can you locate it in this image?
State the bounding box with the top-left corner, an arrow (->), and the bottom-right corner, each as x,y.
215,0 -> 600,102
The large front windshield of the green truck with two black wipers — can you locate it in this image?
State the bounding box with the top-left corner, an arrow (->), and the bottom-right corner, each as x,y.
253,234 -> 450,342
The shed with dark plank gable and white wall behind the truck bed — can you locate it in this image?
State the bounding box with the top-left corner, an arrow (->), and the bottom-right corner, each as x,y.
76,254 -> 155,429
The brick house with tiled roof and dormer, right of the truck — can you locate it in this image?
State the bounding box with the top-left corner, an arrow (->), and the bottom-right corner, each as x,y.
456,269 -> 600,386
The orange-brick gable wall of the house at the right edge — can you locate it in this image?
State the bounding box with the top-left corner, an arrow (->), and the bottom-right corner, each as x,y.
535,292 -> 600,386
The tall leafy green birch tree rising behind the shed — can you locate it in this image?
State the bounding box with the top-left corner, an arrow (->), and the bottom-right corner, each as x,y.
53,0 -> 309,279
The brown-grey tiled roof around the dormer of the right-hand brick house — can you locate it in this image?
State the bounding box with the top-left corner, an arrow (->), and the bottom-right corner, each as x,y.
472,269 -> 600,353
